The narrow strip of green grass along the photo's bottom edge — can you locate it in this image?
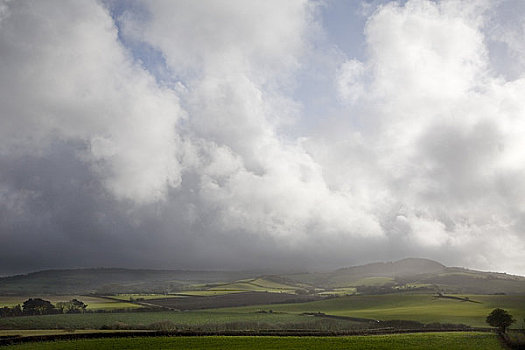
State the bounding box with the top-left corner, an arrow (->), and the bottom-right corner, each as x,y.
0,332 -> 502,350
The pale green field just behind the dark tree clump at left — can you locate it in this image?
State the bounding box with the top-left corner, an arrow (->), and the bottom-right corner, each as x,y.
0,295 -> 142,310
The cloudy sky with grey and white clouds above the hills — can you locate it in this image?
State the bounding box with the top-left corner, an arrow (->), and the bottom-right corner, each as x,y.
0,0 -> 525,275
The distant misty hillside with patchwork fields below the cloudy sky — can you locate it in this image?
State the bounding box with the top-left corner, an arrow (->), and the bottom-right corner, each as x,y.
0,258 -> 525,295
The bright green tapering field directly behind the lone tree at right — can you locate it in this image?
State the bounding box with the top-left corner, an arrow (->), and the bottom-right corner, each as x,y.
209,293 -> 525,327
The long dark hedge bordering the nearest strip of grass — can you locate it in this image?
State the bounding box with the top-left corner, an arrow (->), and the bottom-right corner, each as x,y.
0,328 -> 494,346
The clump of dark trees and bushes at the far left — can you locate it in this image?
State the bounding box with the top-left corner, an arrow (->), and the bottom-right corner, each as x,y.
0,298 -> 87,317
